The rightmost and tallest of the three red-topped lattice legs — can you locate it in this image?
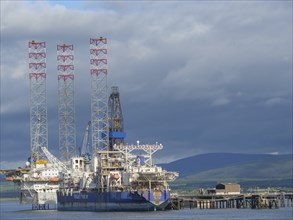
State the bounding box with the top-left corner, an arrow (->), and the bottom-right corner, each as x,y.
90,37 -> 109,158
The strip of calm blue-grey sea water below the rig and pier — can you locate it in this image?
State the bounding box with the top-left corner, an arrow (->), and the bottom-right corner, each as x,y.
0,201 -> 293,220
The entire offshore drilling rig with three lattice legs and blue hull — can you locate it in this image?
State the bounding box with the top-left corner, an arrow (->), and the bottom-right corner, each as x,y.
2,37 -> 179,211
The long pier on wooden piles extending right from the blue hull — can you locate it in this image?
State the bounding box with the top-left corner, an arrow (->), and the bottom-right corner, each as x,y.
167,193 -> 293,210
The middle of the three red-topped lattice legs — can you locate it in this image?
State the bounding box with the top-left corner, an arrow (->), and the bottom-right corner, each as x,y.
57,44 -> 76,161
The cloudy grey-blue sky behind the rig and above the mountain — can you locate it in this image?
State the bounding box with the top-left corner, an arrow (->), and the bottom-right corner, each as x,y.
1,0 -> 292,169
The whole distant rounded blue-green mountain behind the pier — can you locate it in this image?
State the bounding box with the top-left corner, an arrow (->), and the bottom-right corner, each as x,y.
160,153 -> 293,187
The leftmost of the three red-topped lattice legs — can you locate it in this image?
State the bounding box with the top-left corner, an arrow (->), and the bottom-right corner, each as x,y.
28,41 -> 48,166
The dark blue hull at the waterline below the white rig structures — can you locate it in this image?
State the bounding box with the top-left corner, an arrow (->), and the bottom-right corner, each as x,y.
57,190 -> 170,212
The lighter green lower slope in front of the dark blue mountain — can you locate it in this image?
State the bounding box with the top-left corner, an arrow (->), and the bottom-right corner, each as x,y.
172,155 -> 293,188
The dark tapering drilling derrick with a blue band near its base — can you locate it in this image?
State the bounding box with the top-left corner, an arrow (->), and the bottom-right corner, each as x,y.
109,86 -> 126,150
